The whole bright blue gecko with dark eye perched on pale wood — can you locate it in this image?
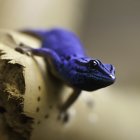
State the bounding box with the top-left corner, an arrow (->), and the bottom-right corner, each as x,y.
16,28 -> 115,115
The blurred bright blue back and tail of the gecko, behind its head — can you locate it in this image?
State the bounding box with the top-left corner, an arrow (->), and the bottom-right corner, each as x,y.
22,28 -> 86,58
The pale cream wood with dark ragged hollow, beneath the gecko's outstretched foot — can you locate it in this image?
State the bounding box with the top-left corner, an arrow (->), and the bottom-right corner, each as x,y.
0,31 -> 62,140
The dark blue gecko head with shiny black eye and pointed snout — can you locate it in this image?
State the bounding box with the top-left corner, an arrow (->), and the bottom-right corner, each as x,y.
67,58 -> 115,91
